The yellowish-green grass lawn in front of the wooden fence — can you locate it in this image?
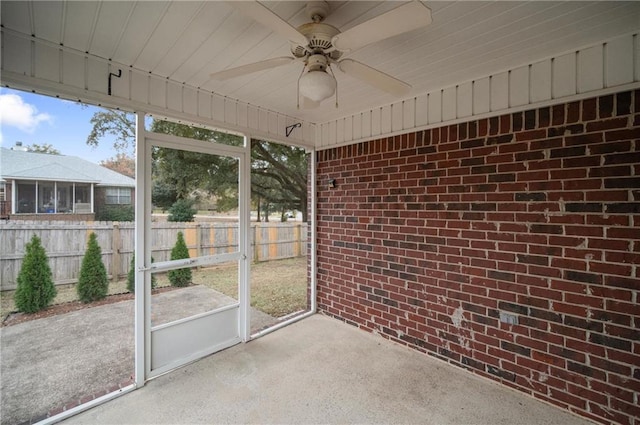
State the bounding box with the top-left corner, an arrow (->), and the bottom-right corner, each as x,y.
0,257 -> 307,317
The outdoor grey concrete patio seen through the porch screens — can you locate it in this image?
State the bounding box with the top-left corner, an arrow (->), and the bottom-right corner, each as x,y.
0,286 -> 276,425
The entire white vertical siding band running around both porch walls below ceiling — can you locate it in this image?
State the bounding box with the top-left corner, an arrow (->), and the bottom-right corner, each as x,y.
0,26 -> 640,148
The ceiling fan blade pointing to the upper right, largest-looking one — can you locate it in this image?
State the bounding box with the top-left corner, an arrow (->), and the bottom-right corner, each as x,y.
331,0 -> 431,52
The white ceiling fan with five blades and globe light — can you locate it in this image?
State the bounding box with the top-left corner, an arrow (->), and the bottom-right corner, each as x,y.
211,0 -> 431,108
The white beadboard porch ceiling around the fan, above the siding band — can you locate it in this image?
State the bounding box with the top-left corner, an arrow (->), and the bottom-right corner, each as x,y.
1,0 -> 640,123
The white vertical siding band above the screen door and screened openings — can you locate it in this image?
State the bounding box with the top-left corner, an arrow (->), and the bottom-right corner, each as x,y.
0,29 -> 316,147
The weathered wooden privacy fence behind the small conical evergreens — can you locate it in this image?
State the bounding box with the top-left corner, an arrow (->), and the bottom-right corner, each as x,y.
0,221 -> 307,290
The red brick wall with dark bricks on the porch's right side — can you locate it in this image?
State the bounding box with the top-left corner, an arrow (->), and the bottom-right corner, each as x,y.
317,90 -> 640,425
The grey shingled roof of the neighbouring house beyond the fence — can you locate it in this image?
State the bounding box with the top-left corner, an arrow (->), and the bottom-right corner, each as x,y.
0,148 -> 136,187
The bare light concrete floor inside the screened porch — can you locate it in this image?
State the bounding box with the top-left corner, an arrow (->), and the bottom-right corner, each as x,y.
64,315 -> 591,425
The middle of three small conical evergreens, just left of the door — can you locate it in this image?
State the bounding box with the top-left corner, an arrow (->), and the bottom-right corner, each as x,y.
76,232 -> 109,303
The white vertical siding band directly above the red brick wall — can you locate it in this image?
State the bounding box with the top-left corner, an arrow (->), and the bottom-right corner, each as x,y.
316,34 -> 640,149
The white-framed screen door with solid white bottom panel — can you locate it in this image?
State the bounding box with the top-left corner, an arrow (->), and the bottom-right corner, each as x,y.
144,133 -> 248,378
